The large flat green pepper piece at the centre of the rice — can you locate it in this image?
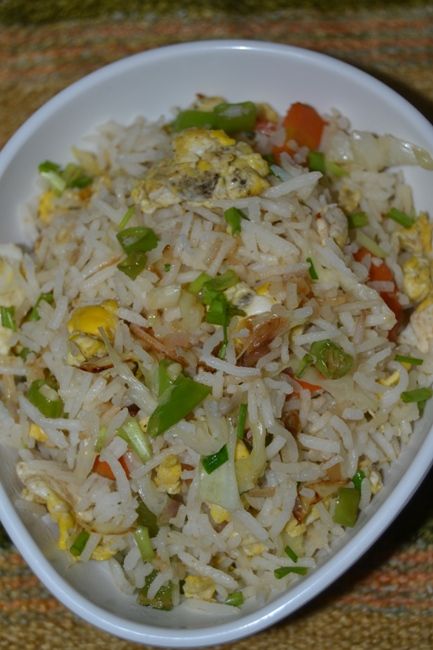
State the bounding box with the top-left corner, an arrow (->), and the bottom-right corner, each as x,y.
147,375 -> 212,437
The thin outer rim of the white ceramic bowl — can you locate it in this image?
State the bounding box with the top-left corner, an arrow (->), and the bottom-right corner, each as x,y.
0,39 -> 433,648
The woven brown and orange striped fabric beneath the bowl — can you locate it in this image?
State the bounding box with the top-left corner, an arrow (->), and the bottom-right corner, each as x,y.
0,0 -> 433,650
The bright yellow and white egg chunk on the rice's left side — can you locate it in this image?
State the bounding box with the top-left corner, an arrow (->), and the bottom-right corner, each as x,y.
67,300 -> 117,365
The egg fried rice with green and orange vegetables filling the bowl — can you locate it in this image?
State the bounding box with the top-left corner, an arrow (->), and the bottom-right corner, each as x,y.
0,95 -> 433,611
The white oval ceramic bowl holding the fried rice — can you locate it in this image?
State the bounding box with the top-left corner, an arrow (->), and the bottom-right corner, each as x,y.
0,41 -> 433,648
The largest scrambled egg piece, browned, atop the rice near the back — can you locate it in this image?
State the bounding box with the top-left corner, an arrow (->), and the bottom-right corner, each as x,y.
132,128 -> 269,213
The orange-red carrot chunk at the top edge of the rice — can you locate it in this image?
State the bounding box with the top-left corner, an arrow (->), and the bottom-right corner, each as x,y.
283,102 -> 326,151
